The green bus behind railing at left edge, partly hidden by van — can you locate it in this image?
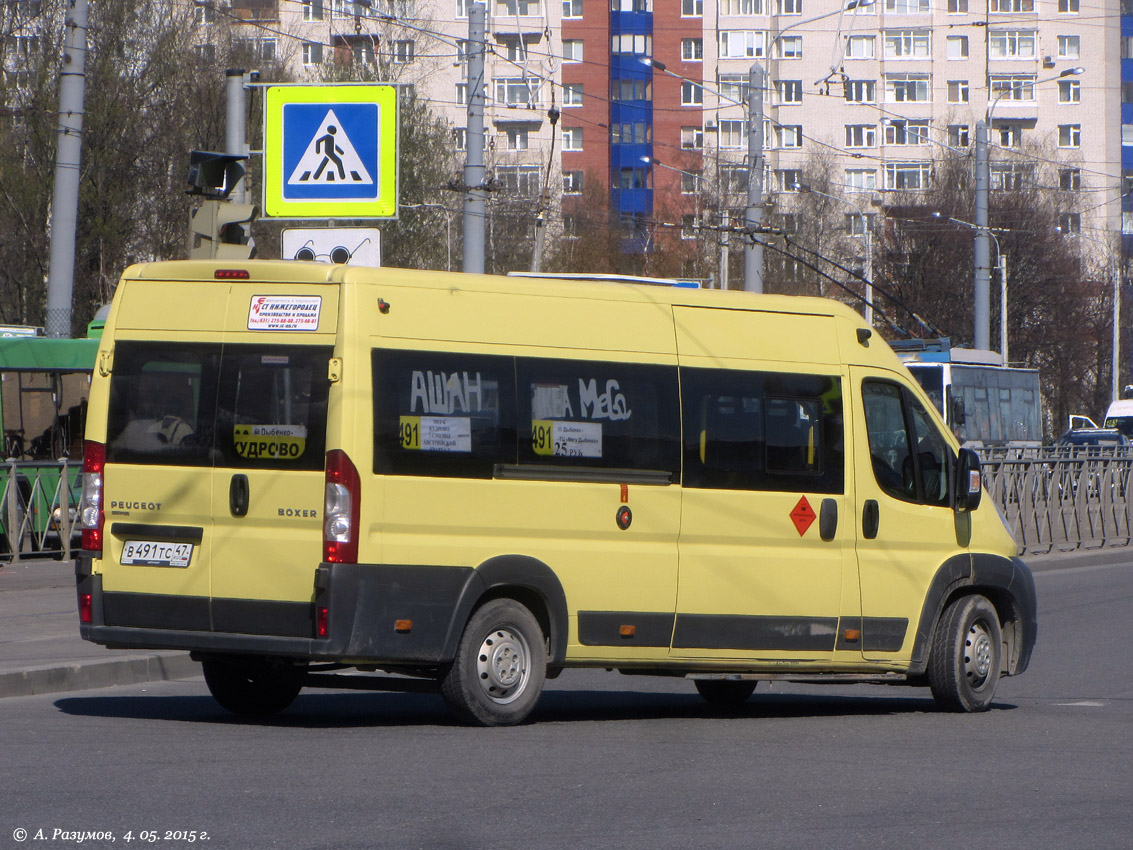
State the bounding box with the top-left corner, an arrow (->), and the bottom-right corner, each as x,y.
0,309 -> 107,561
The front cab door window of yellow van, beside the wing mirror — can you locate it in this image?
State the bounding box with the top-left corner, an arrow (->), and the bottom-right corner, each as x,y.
862,381 -> 952,505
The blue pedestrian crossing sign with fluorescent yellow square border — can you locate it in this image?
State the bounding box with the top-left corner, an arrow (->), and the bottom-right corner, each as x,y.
263,84 -> 398,219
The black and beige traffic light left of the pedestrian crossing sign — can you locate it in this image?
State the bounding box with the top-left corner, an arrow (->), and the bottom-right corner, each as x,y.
188,151 -> 259,260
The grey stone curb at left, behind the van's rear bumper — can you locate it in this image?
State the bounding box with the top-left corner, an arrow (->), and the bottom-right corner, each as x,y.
0,653 -> 201,697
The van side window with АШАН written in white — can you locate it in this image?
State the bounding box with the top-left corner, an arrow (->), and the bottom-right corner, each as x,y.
373,349 -> 516,478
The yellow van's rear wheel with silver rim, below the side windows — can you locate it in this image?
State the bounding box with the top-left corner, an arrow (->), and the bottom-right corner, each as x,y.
441,600 -> 547,726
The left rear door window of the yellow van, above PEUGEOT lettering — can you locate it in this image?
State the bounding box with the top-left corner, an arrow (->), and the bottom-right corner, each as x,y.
107,340 -> 220,466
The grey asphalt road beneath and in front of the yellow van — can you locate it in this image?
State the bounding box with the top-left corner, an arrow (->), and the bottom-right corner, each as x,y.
0,550 -> 1133,850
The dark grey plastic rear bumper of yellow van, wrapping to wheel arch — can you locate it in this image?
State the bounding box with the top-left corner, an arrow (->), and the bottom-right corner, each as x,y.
75,553 -> 484,665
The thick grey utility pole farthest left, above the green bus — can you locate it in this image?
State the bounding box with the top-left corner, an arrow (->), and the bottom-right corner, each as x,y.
45,0 -> 87,339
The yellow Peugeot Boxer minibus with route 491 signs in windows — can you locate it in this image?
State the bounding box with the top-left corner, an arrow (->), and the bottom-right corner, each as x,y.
77,261 -> 1036,725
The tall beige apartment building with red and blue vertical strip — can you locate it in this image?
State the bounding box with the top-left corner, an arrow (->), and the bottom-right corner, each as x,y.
203,0 -> 1119,249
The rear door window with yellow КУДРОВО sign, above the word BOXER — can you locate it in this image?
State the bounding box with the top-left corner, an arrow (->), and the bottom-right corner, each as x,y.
216,346 -> 333,470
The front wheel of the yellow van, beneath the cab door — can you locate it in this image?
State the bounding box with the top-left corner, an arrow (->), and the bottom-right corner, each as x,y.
928,596 -> 1003,712
